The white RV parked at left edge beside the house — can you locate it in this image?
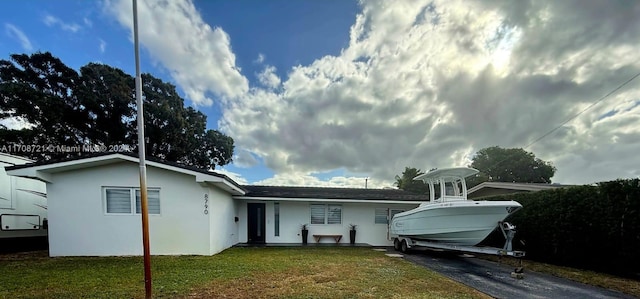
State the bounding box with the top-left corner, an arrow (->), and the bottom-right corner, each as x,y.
0,153 -> 48,241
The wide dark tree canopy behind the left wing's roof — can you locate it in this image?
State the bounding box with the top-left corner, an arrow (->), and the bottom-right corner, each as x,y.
0,52 -> 234,168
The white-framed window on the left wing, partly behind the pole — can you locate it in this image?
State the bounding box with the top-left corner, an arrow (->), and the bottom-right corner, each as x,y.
104,187 -> 160,214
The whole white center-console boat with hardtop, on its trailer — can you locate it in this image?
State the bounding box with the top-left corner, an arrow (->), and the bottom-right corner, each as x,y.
390,167 -> 522,249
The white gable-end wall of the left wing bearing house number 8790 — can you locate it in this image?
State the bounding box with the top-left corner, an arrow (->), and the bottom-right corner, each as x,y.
47,162 -> 220,256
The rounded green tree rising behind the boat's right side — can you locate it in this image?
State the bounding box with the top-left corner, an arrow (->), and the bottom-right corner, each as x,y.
468,146 -> 556,186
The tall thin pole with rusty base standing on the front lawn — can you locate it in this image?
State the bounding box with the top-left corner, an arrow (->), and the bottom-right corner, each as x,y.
133,0 -> 151,298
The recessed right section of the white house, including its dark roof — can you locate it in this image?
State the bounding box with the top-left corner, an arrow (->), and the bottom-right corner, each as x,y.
238,185 -> 425,246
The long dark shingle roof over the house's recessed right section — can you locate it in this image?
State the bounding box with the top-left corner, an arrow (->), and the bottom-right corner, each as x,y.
242,185 -> 429,201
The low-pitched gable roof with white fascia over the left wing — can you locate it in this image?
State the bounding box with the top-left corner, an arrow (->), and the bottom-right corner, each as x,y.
5,152 -> 245,195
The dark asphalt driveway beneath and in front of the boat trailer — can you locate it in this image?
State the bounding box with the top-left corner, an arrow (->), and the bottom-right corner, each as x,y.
387,248 -> 635,298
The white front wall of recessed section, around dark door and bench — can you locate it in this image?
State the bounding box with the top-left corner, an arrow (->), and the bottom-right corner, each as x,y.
237,200 -> 418,246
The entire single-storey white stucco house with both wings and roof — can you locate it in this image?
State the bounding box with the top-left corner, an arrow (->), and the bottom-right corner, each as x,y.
6,153 -> 425,256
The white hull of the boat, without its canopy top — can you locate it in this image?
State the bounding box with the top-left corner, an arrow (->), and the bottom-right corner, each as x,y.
390,200 -> 522,246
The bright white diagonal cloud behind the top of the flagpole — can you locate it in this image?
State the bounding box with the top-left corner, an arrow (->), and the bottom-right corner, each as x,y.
104,0 -> 249,106
